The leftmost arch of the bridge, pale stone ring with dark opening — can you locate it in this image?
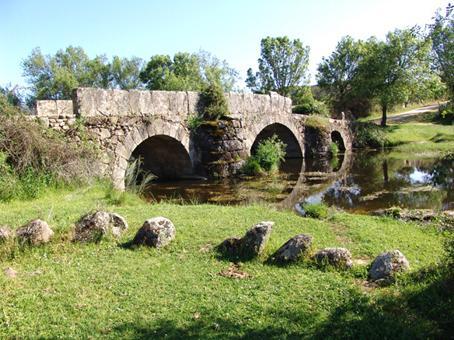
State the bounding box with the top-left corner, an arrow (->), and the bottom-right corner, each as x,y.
112,119 -> 193,189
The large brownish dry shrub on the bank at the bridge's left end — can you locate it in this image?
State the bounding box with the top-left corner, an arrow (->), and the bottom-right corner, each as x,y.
0,112 -> 97,200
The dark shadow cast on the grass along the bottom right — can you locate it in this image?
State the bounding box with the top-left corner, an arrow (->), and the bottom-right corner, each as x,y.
112,266 -> 454,339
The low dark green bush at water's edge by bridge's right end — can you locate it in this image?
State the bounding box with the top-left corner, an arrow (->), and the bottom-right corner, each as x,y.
353,122 -> 390,148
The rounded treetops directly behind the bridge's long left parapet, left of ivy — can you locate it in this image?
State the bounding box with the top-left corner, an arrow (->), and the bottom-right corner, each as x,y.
140,51 -> 238,92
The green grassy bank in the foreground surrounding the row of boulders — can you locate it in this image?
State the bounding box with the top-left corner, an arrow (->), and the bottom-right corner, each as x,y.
0,185 -> 454,339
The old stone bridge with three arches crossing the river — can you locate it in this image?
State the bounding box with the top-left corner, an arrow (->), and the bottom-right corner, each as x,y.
36,88 -> 351,189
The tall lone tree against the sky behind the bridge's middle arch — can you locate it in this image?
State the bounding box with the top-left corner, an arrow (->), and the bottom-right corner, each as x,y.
246,36 -> 309,96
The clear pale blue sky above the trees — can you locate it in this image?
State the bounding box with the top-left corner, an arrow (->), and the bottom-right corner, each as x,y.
0,0 -> 449,86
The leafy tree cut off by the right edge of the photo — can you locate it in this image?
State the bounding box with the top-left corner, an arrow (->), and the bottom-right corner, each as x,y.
430,4 -> 454,100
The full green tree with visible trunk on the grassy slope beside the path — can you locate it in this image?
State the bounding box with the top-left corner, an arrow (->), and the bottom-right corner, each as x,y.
358,29 -> 430,126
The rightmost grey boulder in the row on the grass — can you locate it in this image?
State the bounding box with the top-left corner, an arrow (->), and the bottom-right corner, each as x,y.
369,250 -> 410,281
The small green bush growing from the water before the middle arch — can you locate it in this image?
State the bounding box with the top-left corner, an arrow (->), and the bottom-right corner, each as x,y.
242,135 -> 286,175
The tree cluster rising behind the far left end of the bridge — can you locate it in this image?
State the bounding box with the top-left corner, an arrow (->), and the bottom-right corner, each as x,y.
22,46 -> 143,101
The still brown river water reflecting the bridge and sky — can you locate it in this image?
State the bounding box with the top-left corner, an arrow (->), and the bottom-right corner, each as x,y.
148,151 -> 454,213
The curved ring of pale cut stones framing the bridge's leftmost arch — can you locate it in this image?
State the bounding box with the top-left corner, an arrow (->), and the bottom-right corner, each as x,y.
112,118 -> 192,189
